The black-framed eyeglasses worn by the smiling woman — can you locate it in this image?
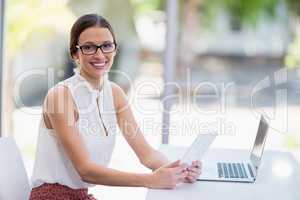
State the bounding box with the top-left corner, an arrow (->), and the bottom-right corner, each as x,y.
76,42 -> 117,55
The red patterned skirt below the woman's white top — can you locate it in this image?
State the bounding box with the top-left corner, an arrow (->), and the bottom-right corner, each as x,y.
29,183 -> 97,200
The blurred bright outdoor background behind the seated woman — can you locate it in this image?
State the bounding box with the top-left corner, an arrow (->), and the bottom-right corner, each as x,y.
2,0 -> 300,199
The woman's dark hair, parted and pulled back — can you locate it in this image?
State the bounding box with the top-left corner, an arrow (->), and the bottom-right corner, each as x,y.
70,14 -> 116,58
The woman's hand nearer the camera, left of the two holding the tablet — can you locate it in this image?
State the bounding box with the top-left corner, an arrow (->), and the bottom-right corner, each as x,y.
149,160 -> 188,189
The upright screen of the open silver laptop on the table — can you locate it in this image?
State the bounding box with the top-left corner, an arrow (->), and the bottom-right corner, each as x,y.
250,116 -> 269,169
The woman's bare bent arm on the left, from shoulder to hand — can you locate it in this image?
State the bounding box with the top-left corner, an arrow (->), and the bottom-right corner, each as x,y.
44,86 -> 186,188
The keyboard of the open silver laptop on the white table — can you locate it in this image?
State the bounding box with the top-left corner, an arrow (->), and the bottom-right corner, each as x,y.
217,162 -> 254,178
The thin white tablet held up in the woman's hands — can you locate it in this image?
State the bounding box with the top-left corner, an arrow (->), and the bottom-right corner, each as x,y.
181,132 -> 217,165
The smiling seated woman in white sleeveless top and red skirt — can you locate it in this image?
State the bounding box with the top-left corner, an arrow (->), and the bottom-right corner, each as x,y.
30,14 -> 200,200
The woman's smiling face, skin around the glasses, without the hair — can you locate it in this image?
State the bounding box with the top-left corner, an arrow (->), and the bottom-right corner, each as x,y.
74,26 -> 116,79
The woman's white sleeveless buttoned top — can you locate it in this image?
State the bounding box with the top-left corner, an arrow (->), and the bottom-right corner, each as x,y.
31,71 -> 117,189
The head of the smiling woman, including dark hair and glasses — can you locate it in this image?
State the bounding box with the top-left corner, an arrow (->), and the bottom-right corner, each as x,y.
70,15 -> 117,83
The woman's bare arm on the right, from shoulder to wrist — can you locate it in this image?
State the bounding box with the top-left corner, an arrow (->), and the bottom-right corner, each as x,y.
112,83 -> 169,170
